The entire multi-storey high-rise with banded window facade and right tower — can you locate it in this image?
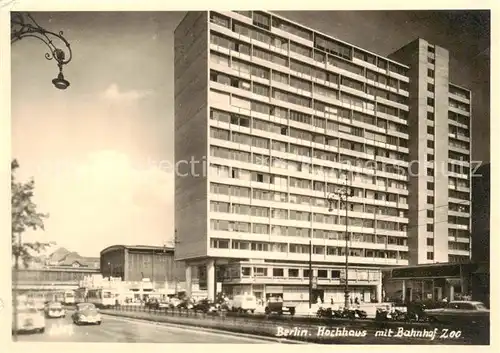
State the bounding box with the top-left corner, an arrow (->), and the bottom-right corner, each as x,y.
175,11 -> 470,303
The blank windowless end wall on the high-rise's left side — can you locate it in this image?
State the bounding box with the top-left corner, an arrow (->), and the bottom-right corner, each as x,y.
174,12 -> 208,259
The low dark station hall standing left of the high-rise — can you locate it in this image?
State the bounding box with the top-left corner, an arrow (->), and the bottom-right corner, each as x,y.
100,245 -> 185,285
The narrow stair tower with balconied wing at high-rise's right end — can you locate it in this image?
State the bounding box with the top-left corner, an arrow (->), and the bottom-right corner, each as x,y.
390,38 -> 471,265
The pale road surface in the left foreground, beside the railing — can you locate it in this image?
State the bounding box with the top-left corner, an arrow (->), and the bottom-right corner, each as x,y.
12,313 -> 278,344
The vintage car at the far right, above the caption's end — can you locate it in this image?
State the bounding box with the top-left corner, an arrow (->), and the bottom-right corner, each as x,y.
425,300 -> 490,323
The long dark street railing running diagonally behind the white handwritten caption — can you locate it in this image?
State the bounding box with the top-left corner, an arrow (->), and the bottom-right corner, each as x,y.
102,305 -> 489,344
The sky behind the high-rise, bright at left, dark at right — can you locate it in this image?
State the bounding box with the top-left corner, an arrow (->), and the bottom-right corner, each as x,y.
11,11 -> 490,256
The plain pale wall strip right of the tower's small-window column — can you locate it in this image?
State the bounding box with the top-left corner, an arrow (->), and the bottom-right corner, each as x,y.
432,46 -> 450,262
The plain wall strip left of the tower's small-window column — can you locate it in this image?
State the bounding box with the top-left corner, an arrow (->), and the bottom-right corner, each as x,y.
389,39 -> 428,265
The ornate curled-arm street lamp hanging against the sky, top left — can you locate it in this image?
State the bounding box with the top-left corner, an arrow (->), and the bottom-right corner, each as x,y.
10,12 -> 72,90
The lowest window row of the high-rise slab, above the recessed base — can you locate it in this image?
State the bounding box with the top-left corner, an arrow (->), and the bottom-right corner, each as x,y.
210,238 -> 408,260
